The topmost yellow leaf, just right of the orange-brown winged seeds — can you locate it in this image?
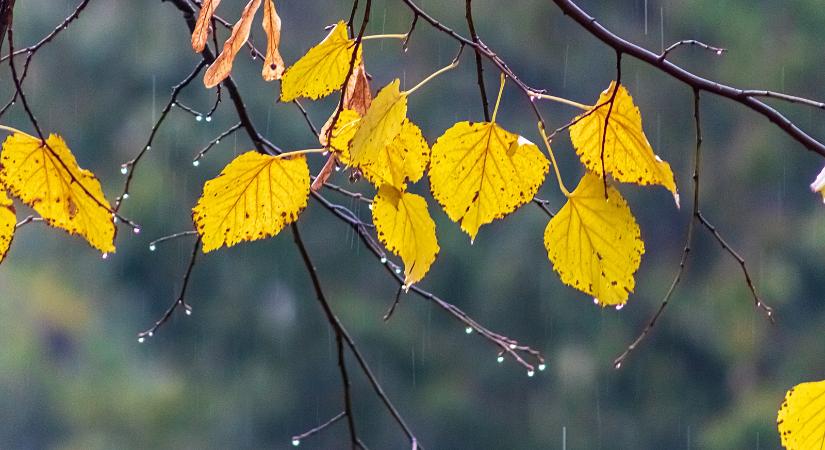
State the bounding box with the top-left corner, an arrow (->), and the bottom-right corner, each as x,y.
281,21 -> 361,102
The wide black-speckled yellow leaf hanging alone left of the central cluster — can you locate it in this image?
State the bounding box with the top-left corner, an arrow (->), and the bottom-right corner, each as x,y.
192,151 -> 309,253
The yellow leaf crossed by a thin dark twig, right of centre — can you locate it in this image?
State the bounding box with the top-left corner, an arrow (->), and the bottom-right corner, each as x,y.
570,82 -> 679,206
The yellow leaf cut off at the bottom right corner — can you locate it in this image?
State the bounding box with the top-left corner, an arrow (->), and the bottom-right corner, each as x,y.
776,381 -> 825,450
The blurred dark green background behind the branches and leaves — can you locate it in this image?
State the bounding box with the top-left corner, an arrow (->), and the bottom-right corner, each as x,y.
0,0 -> 825,449
